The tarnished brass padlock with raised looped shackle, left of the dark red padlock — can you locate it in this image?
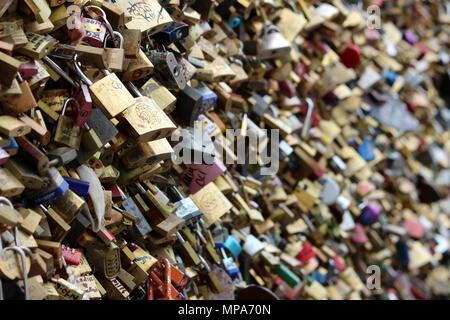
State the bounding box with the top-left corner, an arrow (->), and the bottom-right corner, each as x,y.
53,98 -> 82,150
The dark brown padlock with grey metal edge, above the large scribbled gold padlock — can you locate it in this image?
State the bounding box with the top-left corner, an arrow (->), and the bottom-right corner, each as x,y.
149,52 -> 186,90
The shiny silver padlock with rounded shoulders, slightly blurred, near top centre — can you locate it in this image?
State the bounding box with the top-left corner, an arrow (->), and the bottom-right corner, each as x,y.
259,25 -> 291,59
